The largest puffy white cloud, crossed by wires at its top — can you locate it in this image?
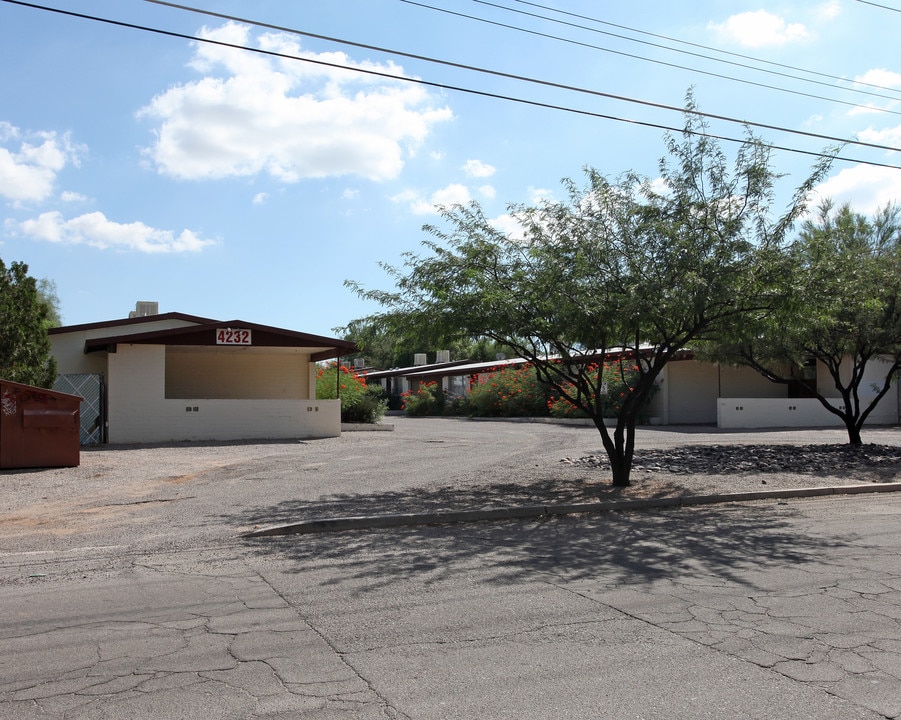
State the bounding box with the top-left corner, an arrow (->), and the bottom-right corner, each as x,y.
139,23 -> 452,182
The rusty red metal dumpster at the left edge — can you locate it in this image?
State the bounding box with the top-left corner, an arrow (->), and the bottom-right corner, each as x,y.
0,380 -> 81,469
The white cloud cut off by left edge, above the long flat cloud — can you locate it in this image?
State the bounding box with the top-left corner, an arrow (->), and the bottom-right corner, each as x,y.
0,122 -> 82,204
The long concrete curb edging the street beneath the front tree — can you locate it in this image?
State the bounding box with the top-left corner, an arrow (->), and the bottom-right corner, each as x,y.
241,483 -> 901,538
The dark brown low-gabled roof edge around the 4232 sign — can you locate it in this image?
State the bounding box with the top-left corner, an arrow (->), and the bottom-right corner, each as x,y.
57,313 -> 357,361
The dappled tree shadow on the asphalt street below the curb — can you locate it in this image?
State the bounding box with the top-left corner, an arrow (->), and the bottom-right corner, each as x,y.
230,498 -> 846,593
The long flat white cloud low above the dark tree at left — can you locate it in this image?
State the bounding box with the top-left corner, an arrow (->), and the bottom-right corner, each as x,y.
16,211 -> 213,253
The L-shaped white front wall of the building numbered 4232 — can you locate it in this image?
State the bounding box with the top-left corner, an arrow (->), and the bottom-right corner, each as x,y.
107,343 -> 341,443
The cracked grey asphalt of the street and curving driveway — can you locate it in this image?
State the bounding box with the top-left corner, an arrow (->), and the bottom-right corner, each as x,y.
0,421 -> 901,720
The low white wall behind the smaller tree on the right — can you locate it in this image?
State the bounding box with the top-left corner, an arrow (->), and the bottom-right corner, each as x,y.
717,397 -> 898,428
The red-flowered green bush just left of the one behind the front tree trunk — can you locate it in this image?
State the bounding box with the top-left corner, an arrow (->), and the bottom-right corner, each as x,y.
469,365 -> 549,417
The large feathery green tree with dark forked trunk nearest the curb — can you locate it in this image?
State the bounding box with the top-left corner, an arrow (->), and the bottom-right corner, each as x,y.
348,107 -> 828,485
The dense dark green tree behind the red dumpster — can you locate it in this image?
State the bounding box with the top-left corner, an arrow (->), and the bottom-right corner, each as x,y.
0,260 -> 56,388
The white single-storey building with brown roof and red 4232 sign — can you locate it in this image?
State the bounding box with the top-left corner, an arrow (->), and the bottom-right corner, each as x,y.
49,303 -> 356,443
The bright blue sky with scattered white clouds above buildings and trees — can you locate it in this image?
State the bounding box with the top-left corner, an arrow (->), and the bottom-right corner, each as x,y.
0,0 -> 901,336
